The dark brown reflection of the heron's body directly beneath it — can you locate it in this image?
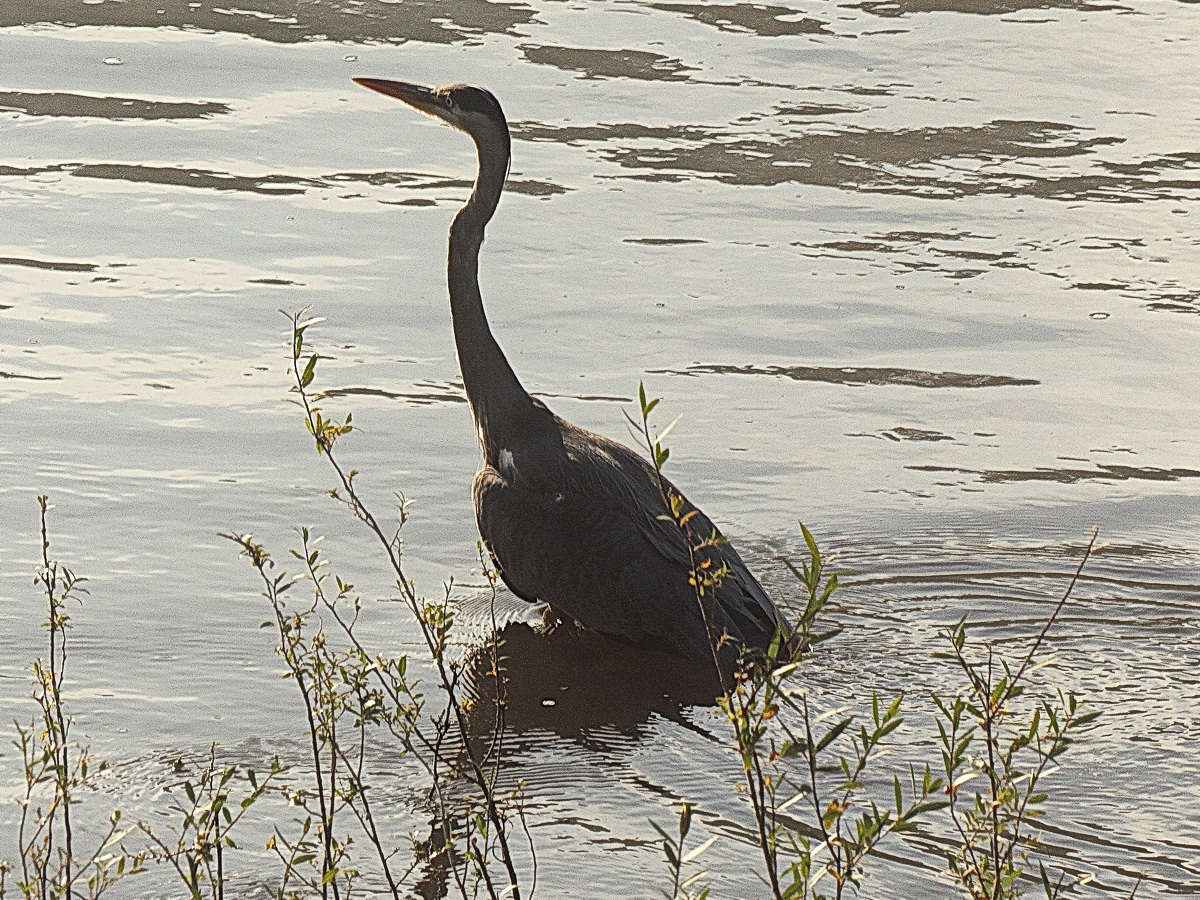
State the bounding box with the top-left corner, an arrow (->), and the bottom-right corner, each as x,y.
470,622 -> 720,739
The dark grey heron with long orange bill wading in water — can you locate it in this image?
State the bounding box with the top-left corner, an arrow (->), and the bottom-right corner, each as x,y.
354,78 -> 782,670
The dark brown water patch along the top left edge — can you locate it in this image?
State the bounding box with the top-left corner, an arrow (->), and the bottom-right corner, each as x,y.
0,0 -> 538,43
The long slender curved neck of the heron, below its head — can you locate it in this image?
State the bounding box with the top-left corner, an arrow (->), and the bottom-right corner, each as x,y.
448,130 -> 532,448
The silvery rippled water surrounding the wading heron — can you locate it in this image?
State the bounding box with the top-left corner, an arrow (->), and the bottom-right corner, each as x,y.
0,0 -> 1200,898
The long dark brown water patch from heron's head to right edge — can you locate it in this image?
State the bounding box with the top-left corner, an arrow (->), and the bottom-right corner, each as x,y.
515,120 -> 1200,203
